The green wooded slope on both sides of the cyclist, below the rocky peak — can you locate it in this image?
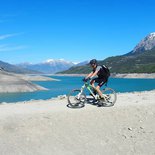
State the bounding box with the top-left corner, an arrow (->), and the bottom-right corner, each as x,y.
58,48 -> 155,74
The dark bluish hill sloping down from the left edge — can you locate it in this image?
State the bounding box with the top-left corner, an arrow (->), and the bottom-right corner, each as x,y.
0,61 -> 39,74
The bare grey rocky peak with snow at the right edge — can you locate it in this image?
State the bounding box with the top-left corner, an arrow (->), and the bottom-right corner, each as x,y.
131,32 -> 155,54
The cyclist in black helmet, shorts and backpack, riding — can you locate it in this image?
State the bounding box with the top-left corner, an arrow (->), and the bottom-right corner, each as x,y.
83,59 -> 108,99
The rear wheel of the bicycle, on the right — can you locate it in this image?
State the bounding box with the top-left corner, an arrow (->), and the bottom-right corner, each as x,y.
102,88 -> 117,107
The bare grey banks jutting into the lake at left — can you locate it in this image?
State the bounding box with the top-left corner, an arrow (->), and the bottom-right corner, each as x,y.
0,71 -> 56,93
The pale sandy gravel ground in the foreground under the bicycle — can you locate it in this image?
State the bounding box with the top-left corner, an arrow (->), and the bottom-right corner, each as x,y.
0,91 -> 155,155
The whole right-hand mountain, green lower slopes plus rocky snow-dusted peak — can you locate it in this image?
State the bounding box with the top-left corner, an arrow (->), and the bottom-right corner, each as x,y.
61,32 -> 155,74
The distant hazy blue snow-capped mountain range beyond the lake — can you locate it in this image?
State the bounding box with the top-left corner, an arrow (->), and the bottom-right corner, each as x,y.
17,59 -> 75,74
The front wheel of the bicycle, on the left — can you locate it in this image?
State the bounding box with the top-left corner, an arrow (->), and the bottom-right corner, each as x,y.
67,89 -> 86,108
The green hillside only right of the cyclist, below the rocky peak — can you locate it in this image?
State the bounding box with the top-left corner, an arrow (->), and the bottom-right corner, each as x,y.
101,49 -> 155,73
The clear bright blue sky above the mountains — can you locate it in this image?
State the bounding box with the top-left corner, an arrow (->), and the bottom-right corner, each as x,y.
0,0 -> 155,64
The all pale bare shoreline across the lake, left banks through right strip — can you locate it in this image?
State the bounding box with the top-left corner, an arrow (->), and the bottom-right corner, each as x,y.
0,71 -> 155,93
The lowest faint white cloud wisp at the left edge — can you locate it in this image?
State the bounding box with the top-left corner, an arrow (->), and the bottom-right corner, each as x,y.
0,44 -> 27,52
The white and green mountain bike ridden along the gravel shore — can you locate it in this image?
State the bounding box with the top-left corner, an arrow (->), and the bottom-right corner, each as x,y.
67,81 -> 117,108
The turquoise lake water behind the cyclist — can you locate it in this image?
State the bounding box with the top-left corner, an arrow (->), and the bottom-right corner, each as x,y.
0,76 -> 155,103
